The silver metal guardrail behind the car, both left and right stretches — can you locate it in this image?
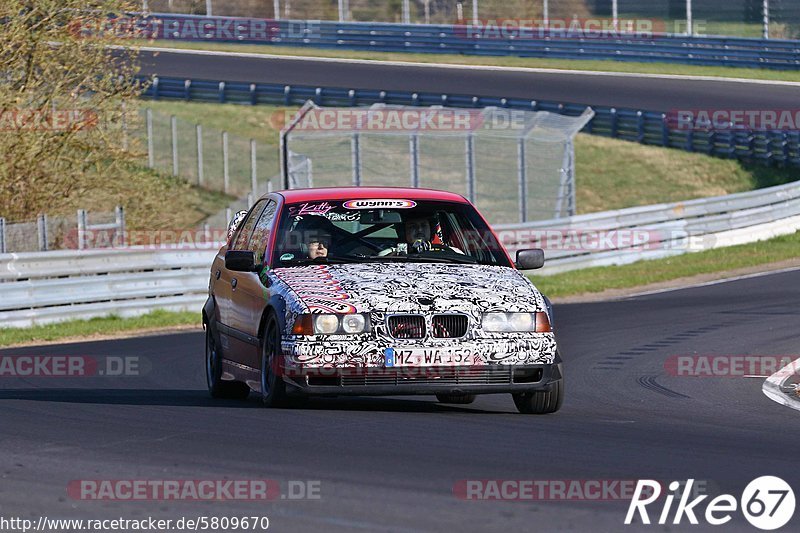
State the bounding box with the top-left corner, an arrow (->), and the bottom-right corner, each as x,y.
0,183 -> 800,327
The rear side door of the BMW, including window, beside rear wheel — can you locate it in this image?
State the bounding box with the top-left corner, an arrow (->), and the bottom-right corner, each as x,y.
214,199 -> 269,364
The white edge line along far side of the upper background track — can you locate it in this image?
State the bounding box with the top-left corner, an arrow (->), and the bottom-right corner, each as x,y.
140,46 -> 800,87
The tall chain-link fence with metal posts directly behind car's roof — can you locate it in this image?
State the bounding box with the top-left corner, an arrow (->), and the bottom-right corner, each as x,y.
283,103 -> 594,224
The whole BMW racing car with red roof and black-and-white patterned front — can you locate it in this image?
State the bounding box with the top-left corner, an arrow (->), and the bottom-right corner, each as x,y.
202,187 -> 564,414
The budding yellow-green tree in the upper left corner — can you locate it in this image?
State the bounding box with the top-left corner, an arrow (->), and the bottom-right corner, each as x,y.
0,0 -> 141,219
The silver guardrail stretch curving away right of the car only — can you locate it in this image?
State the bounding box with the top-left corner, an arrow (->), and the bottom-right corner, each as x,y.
495,182 -> 800,275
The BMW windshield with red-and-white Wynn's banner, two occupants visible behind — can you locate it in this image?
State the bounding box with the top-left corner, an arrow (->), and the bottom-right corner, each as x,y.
272,198 -> 511,267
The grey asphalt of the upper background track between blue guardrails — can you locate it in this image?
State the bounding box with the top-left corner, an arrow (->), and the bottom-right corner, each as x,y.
141,52 -> 800,111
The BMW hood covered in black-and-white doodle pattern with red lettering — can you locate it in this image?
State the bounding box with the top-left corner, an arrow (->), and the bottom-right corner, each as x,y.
270,263 -> 545,313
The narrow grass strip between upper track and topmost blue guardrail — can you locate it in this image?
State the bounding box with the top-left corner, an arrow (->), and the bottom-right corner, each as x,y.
138,41 -> 800,82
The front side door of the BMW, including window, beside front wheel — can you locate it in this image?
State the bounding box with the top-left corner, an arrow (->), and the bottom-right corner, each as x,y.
230,199 -> 279,368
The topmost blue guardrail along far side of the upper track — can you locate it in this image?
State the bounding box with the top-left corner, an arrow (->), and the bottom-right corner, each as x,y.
148,15 -> 800,70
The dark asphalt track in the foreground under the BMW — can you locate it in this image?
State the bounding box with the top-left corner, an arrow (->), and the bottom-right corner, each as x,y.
0,271 -> 800,532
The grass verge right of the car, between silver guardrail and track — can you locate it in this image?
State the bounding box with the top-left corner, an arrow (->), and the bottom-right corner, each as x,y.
531,232 -> 800,298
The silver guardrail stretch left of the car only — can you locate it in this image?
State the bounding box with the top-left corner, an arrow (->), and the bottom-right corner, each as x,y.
0,249 -> 216,327
